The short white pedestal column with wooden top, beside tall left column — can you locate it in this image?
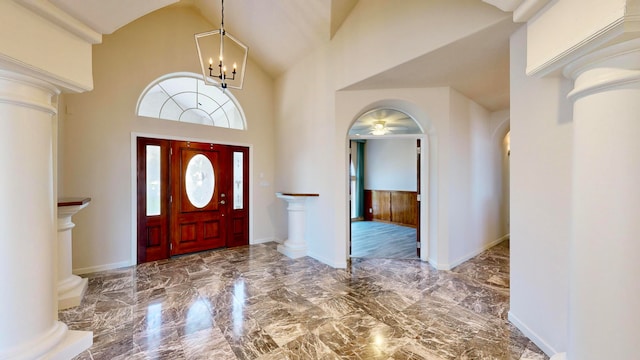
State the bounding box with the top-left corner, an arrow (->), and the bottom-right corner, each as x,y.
58,198 -> 91,310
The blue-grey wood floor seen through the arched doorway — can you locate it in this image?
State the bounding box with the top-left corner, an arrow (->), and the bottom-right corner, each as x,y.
351,221 -> 418,259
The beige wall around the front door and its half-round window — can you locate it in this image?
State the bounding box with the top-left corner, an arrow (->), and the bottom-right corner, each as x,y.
60,7 -> 276,272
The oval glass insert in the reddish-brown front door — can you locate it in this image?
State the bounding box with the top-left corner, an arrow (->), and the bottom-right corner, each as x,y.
185,154 -> 216,209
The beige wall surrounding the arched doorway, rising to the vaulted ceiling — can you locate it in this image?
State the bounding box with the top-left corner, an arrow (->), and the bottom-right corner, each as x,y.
276,0 -> 508,266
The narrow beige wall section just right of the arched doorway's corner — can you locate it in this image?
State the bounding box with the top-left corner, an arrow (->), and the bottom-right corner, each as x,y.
440,90 -> 505,267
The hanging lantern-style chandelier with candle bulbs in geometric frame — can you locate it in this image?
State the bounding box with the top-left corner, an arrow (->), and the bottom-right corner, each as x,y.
195,0 -> 249,89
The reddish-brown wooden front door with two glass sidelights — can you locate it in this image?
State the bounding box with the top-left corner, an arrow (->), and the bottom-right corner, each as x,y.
136,137 -> 249,263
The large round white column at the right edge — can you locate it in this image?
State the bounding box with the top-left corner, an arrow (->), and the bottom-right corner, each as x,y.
564,39 -> 640,360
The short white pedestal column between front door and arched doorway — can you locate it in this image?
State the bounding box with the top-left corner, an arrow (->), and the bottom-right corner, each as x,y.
276,193 -> 318,259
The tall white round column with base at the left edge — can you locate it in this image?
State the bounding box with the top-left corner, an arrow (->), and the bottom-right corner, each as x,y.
0,70 -> 92,359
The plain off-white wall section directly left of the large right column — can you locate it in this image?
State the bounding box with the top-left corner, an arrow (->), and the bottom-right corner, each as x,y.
509,29 -> 573,354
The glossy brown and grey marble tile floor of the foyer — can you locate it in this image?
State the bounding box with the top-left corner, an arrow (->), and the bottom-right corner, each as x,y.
59,242 -> 548,360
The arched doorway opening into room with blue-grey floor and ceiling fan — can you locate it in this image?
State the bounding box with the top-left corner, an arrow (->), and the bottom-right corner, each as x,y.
349,109 -> 422,259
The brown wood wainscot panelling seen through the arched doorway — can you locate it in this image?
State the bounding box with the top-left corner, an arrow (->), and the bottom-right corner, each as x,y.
364,189 -> 418,227
